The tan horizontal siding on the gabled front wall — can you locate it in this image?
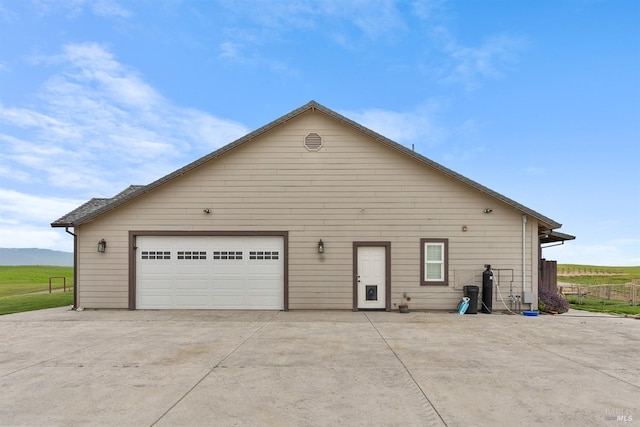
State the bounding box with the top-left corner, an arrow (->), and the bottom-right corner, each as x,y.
76,111 -> 538,309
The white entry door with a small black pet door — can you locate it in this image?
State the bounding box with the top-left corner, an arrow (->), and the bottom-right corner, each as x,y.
357,246 -> 387,309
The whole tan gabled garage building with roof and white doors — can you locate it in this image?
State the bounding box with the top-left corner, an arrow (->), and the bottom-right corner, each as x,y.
52,101 -> 573,310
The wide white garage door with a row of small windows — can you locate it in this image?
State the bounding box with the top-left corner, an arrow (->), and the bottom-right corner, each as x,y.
136,236 -> 284,310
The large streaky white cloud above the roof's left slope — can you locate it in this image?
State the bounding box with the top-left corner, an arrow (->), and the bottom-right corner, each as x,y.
0,43 -> 248,196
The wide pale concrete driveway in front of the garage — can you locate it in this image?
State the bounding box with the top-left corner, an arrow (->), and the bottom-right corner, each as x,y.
0,308 -> 640,426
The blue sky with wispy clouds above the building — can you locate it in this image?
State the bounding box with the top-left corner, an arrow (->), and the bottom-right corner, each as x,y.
0,0 -> 640,265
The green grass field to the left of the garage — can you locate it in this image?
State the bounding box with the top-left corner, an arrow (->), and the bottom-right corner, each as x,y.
0,265 -> 73,315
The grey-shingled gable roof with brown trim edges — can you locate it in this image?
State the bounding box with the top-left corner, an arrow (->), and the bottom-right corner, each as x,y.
51,101 -> 562,230
